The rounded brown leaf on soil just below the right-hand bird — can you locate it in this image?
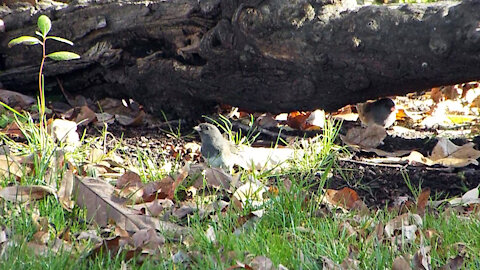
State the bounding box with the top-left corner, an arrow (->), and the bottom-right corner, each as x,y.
340,125 -> 387,149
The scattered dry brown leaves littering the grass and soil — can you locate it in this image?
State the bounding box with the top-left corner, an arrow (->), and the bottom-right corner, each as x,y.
0,83 -> 480,269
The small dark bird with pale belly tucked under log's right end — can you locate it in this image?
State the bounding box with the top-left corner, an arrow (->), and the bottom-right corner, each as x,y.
357,98 -> 396,128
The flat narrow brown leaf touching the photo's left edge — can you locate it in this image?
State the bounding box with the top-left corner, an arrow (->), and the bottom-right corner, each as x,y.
0,185 -> 55,203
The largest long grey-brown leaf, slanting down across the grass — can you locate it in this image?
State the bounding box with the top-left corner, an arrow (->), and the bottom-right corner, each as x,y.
74,176 -> 187,235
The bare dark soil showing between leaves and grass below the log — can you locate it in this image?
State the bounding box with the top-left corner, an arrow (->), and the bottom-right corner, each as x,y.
96,120 -> 480,208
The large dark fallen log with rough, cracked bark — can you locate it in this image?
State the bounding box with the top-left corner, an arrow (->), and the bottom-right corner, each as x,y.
0,0 -> 480,116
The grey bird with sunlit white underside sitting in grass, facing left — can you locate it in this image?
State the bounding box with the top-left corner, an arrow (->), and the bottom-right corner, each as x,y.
194,123 -> 303,170
